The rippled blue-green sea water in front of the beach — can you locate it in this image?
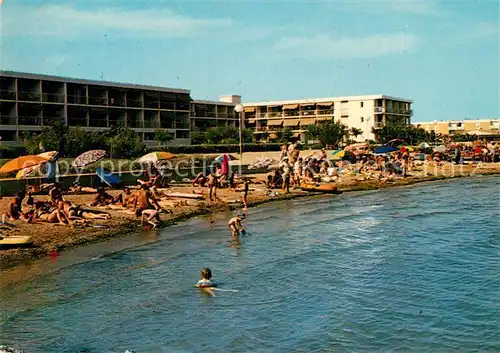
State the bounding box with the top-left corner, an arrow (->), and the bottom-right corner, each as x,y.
0,177 -> 500,353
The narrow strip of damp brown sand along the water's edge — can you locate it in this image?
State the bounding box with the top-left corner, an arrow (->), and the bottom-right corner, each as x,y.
0,165 -> 500,272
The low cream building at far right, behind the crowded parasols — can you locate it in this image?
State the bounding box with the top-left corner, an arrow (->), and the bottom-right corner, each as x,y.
413,118 -> 500,138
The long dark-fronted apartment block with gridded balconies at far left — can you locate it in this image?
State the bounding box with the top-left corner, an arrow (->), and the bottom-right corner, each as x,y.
0,71 -> 191,145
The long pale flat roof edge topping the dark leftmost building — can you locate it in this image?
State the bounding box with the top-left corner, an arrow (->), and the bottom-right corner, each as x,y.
0,70 -> 191,94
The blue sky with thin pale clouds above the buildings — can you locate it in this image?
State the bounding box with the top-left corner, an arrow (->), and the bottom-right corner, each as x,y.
0,0 -> 500,121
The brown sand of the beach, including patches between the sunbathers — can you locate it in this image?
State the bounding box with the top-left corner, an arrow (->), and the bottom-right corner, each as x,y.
0,163 -> 500,270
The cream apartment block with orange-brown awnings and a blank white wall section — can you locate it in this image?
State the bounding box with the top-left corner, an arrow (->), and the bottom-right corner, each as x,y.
243,95 -> 413,141
